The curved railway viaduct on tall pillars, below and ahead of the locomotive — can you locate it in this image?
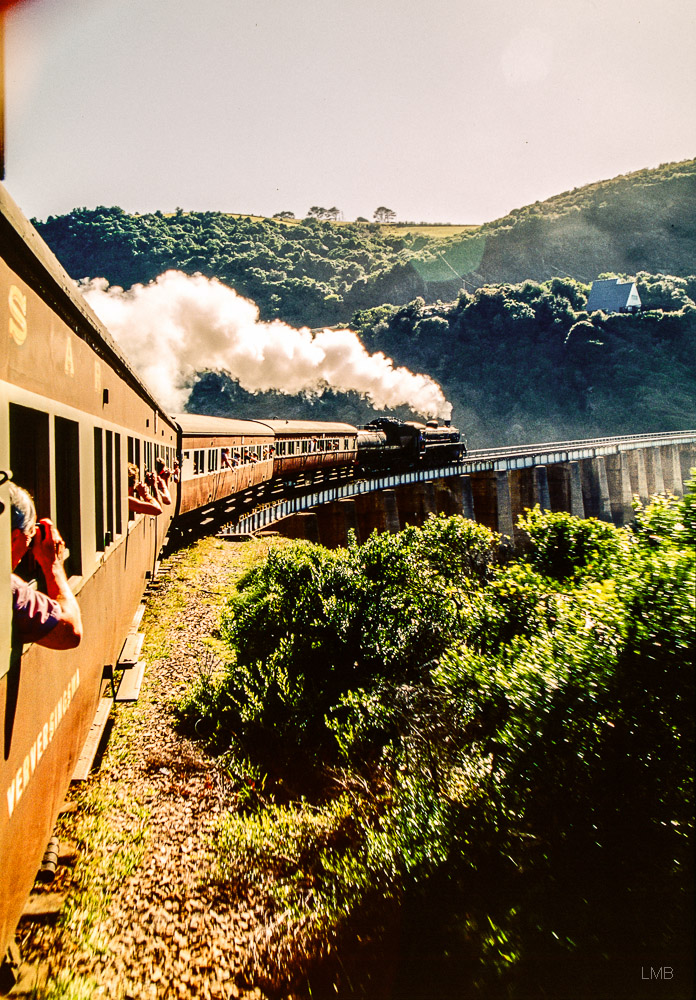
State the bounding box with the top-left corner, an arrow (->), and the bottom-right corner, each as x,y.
223,431 -> 696,547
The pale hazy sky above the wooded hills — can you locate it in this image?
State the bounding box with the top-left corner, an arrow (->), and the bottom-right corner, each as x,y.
5,0 -> 696,222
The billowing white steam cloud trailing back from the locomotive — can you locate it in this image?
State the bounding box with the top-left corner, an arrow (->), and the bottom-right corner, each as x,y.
82,271 -> 452,419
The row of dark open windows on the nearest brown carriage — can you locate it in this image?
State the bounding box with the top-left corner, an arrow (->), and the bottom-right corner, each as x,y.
9,403 -> 176,576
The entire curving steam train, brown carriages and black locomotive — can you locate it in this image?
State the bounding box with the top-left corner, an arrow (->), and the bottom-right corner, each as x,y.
0,180 -> 463,962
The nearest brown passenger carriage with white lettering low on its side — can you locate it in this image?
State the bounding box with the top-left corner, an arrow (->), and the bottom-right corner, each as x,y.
0,187 -> 178,955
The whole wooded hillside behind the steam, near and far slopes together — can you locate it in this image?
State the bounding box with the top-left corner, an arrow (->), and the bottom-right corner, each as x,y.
31,160 -> 696,446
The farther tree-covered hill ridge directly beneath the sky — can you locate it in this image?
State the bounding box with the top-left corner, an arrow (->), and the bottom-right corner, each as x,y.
35,160 -> 696,327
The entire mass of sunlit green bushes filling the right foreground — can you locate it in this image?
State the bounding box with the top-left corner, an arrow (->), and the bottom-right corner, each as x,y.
181,492 -> 696,998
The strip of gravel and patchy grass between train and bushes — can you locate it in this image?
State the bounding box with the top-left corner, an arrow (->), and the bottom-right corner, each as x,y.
20,538 -> 282,1000
